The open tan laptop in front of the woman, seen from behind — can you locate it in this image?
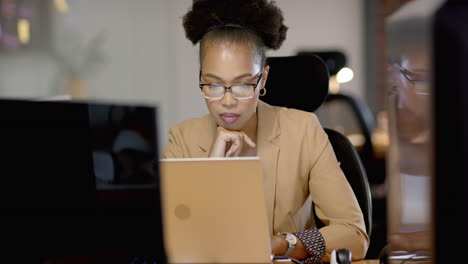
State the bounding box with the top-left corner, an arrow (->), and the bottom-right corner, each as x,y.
160,157 -> 272,263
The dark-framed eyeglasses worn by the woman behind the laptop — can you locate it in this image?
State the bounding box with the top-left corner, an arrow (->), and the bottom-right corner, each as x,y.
200,71 -> 263,100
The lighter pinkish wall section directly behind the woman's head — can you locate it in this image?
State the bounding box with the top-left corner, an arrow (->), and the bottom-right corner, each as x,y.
169,0 -> 365,128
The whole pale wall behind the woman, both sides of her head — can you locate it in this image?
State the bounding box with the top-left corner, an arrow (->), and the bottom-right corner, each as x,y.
0,0 -> 364,151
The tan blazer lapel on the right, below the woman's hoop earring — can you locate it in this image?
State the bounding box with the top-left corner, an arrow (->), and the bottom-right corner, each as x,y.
257,101 -> 280,234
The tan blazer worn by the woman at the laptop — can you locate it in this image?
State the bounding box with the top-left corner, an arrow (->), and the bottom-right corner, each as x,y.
163,101 -> 369,260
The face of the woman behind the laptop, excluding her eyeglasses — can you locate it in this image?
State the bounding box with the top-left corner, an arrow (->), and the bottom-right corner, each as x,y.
200,41 -> 268,131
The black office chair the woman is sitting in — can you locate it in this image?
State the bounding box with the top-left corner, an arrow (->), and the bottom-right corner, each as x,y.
261,55 -> 372,236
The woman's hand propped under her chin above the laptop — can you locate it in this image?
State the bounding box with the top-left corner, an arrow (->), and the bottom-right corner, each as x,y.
209,126 -> 256,157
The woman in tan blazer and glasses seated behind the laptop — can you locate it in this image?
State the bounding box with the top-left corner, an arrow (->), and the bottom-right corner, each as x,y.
163,0 -> 369,263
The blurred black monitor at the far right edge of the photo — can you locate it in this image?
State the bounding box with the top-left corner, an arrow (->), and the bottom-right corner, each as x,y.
432,0 -> 468,263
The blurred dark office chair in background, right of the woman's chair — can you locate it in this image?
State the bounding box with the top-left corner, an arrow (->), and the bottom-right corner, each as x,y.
315,93 -> 387,258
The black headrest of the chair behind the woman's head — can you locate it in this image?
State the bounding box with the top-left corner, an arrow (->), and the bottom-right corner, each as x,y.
260,55 -> 329,112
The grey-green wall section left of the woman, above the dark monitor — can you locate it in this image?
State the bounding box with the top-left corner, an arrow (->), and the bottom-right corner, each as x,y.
0,0 -> 170,152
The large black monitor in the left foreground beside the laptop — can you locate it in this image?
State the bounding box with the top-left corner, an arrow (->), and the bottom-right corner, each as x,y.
0,100 -> 166,263
